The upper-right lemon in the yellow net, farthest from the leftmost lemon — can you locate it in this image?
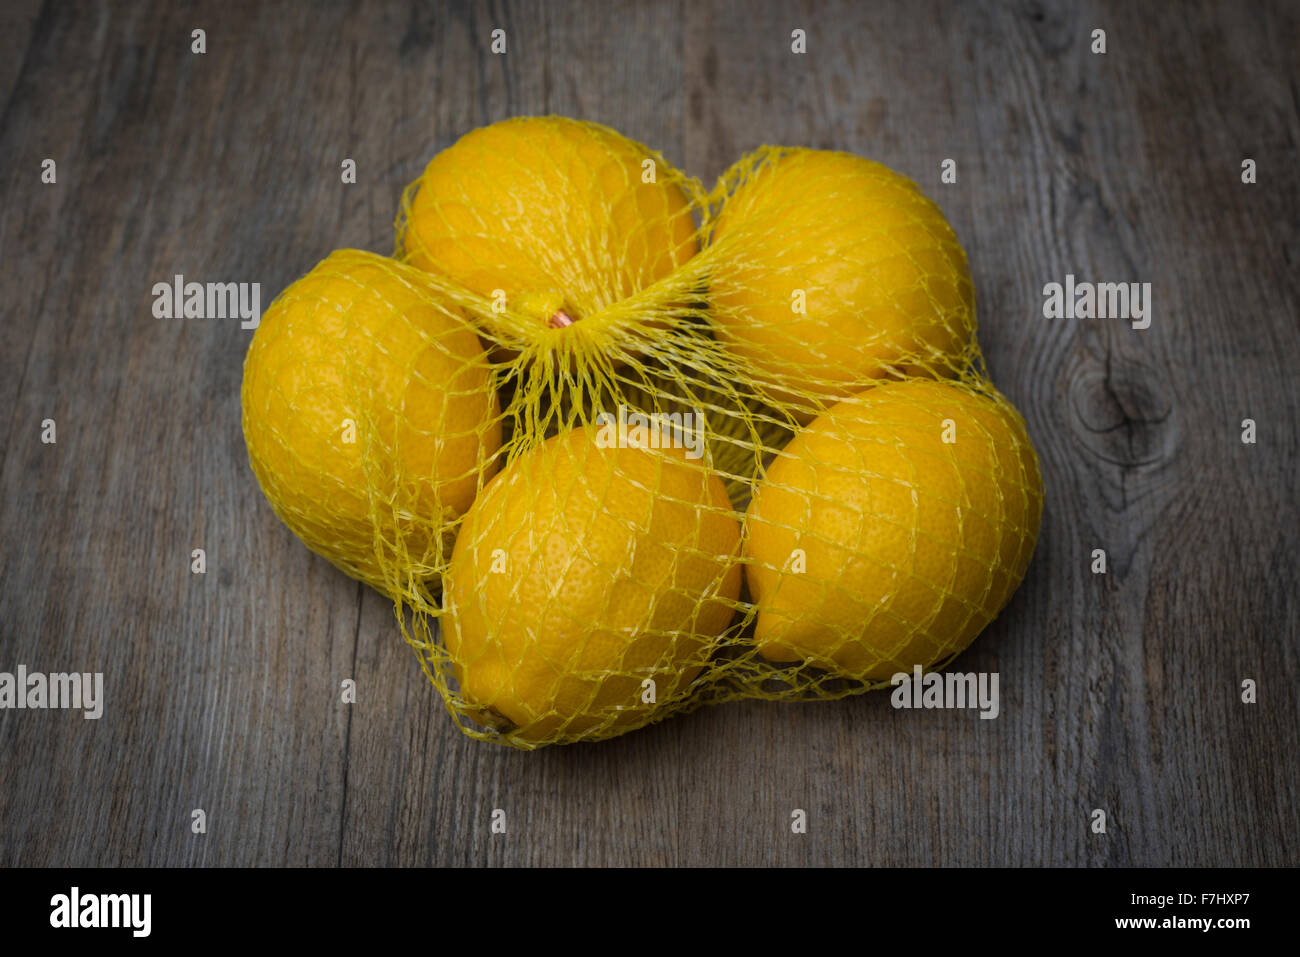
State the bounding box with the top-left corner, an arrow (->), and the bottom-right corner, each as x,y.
710,148 -> 975,421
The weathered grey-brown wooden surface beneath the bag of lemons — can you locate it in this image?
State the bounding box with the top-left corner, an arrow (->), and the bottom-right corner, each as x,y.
0,1 -> 1300,865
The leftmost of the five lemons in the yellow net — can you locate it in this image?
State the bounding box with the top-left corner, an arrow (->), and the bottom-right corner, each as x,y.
242,250 -> 501,588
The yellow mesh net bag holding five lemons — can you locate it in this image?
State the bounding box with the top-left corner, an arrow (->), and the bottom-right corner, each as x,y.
243,117 -> 1043,749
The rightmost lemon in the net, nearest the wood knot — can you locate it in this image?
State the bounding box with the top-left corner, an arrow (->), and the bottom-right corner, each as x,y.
745,380 -> 1043,679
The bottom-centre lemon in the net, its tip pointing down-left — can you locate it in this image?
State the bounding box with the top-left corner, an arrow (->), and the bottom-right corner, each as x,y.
442,426 -> 741,745
